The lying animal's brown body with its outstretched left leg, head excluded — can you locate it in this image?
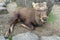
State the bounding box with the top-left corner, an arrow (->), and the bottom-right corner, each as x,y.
6,8 -> 44,36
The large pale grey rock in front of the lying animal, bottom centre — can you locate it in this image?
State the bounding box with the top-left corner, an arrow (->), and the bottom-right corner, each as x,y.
13,32 -> 39,40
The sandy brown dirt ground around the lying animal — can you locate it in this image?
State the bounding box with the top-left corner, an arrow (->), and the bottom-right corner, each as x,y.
0,4 -> 60,36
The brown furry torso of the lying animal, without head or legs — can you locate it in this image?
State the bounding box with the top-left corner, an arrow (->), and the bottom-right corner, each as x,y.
10,8 -> 41,27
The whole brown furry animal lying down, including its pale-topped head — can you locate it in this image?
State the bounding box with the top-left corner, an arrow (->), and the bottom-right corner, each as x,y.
5,2 -> 48,38
